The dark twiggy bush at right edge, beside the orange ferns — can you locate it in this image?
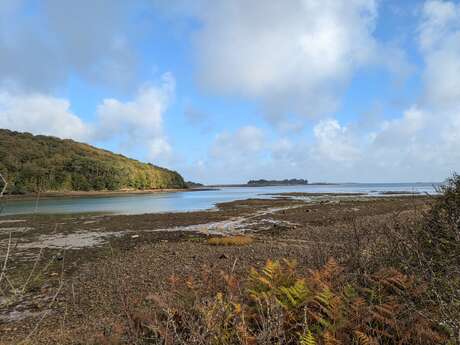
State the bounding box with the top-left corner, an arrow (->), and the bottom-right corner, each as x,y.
368,174 -> 460,344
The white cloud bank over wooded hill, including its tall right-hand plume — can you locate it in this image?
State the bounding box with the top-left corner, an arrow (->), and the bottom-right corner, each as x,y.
0,73 -> 175,161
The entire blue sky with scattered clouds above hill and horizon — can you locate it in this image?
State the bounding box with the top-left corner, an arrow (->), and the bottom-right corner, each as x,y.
0,0 -> 460,184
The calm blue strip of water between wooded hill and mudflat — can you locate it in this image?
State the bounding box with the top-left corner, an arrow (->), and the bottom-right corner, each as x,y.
2,183 -> 435,215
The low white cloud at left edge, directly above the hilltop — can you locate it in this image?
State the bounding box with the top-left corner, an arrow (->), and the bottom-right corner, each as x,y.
0,91 -> 92,140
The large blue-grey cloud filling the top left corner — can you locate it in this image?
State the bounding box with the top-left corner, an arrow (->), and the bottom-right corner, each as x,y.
0,0 -> 135,92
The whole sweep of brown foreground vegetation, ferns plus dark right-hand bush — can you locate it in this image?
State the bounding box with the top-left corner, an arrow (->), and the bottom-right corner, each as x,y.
90,176 -> 460,345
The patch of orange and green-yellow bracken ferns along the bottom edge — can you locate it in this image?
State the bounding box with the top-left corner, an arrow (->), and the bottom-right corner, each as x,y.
96,259 -> 447,345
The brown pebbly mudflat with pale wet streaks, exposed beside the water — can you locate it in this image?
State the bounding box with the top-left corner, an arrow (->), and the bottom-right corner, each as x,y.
0,195 -> 431,344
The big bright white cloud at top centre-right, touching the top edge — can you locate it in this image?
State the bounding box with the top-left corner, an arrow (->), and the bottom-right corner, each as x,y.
195,0 -> 377,124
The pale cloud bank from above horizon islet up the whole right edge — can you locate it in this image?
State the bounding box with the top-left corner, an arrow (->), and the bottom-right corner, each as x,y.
266,0 -> 460,180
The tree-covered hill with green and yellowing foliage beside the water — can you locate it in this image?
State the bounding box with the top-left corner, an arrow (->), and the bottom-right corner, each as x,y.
0,129 -> 186,194
